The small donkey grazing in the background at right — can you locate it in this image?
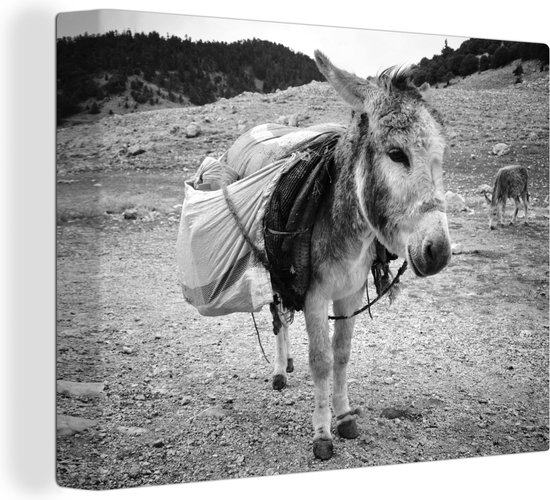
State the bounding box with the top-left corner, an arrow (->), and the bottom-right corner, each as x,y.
483,165 -> 529,229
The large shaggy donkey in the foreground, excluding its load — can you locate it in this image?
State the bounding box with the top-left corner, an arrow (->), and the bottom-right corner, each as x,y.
230,51 -> 451,460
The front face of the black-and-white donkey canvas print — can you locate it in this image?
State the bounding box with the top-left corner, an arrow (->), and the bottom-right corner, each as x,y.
56,10 -> 549,489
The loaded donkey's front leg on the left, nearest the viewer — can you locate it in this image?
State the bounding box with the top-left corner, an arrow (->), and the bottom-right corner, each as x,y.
304,291 -> 333,460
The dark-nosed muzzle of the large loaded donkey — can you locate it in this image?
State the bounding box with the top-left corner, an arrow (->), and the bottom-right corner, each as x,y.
407,212 -> 451,277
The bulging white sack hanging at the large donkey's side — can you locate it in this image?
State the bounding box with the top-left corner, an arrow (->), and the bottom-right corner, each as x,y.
176,161 -> 289,316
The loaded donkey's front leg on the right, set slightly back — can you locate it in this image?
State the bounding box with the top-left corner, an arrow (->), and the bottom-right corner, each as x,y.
332,289 -> 363,439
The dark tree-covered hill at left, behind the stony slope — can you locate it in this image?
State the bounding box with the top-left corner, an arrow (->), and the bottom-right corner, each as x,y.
57,31 -> 322,123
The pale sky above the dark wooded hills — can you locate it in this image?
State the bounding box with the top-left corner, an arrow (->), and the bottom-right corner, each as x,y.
57,10 -> 466,77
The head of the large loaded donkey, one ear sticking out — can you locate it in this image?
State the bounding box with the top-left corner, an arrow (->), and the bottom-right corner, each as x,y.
315,51 -> 451,276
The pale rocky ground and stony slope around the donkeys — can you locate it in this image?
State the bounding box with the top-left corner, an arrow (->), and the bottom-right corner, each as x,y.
57,61 -> 549,489
